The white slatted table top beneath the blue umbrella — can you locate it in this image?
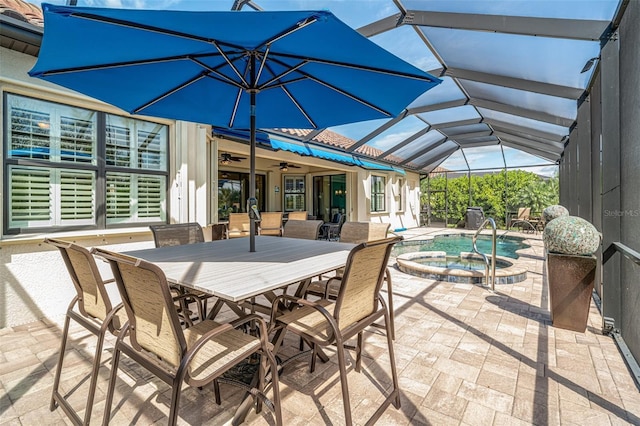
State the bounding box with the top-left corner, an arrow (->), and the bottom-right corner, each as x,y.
125,236 -> 355,302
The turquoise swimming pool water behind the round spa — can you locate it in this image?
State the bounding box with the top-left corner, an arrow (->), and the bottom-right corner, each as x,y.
393,234 -> 530,259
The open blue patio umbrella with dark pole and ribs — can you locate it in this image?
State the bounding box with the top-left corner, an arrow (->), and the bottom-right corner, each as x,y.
29,4 -> 440,251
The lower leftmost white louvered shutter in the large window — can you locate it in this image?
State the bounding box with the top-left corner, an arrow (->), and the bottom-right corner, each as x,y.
9,167 -> 52,227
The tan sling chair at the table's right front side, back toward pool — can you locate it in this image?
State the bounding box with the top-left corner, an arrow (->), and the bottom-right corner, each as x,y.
271,237 -> 401,425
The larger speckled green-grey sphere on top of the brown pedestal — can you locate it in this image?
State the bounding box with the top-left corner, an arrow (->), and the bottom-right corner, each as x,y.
542,216 -> 600,255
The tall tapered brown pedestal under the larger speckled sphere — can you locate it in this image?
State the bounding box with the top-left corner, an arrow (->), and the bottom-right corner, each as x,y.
547,253 -> 597,333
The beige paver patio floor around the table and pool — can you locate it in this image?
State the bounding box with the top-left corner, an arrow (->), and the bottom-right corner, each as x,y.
0,228 -> 640,426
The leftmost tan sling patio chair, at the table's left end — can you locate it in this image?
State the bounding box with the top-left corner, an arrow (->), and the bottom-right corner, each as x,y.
44,238 -> 127,425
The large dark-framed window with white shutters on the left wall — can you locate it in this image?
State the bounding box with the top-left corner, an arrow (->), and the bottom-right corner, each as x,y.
4,94 -> 168,234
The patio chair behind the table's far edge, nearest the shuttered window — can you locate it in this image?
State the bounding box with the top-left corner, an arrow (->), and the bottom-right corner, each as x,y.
149,222 -> 213,323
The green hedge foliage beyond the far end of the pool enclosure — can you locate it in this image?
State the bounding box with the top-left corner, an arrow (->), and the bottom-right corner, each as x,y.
421,170 -> 559,230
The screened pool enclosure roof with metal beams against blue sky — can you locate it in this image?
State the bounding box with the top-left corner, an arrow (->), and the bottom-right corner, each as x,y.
233,0 -> 626,173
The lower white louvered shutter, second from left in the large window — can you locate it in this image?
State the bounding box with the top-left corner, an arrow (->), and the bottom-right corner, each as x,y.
60,170 -> 95,224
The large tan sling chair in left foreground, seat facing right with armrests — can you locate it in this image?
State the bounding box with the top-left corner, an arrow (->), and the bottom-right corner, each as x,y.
94,248 -> 282,425
